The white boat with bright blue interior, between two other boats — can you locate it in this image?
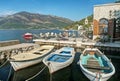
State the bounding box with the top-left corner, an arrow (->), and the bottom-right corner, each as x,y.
43,47 -> 75,74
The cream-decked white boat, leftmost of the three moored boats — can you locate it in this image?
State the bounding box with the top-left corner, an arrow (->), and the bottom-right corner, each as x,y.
9,45 -> 54,71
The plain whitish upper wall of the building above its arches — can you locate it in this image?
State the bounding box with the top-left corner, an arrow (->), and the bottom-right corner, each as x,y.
94,3 -> 120,21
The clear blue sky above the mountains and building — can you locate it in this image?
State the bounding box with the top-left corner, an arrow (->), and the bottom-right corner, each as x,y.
0,0 -> 116,21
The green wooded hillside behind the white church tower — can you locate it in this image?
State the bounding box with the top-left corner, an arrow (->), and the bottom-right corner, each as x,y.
65,15 -> 93,30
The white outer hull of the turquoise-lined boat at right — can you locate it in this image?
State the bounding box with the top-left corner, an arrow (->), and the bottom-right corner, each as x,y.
80,48 -> 115,81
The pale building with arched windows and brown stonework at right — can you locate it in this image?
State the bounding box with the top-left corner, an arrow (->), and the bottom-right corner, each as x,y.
93,3 -> 120,41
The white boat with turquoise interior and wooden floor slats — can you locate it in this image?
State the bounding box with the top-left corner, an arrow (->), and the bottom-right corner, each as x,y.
79,48 -> 115,81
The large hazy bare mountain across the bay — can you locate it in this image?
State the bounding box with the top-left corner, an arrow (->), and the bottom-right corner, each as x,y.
0,11 -> 73,29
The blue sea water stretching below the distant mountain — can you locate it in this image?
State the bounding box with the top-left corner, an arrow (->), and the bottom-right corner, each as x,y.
0,29 -> 78,42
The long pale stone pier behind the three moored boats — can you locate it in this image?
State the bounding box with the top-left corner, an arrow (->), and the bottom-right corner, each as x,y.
33,38 -> 120,52
